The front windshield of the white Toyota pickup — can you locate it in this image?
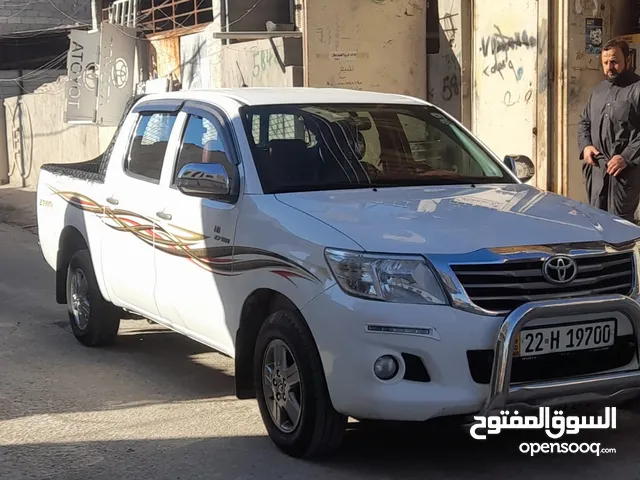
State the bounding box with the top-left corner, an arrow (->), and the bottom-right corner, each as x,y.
241,104 -> 517,193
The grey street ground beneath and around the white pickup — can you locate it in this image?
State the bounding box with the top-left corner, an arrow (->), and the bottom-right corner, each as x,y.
0,188 -> 640,480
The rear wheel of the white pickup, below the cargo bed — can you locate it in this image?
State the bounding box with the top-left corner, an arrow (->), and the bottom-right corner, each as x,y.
67,250 -> 120,347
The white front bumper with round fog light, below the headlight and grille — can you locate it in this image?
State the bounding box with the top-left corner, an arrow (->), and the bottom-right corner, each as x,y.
302,286 -> 640,421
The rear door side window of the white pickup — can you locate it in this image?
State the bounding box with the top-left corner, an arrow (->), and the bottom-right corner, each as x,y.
124,112 -> 176,183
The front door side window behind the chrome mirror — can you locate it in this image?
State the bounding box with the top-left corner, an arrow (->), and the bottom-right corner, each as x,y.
171,115 -> 229,185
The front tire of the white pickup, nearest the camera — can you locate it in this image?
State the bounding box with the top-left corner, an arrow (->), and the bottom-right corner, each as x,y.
253,310 -> 348,459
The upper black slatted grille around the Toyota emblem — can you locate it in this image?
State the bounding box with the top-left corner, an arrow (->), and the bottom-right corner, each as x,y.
451,253 -> 634,312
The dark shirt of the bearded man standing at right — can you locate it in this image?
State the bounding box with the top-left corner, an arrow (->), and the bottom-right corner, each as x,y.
578,72 -> 640,166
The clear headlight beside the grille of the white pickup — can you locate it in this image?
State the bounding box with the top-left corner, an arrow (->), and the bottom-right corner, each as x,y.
325,248 -> 448,305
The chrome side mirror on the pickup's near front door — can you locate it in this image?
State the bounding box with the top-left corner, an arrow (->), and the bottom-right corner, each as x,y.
176,163 -> 233,199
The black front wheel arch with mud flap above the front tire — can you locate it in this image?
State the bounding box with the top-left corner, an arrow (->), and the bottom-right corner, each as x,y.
235,288 -> 314,400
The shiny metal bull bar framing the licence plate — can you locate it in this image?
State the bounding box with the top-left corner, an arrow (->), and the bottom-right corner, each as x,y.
480,295 -> 640,416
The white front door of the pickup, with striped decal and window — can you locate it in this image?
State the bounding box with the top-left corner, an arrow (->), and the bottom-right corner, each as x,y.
155,107 -> 238,352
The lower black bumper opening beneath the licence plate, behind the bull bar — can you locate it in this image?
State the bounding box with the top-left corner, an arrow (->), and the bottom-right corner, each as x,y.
467,334 -> 638,385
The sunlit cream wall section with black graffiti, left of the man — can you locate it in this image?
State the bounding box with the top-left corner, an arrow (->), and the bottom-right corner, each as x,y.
427,0 -> 561,189
